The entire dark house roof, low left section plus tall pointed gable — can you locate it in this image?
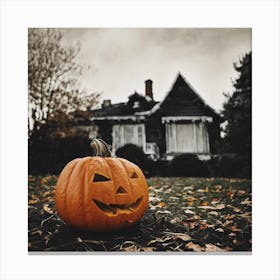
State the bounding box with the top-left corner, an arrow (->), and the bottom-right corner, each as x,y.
90,73 -> 220,120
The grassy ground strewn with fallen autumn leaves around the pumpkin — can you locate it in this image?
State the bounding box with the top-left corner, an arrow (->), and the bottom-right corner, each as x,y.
28,175 -> 252,252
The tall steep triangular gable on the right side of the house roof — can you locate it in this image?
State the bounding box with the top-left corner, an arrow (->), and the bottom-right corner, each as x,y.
148,73 -> 219,117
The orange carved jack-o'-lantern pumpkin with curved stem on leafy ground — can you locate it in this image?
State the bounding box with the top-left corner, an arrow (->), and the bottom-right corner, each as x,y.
55,139 -> 148,231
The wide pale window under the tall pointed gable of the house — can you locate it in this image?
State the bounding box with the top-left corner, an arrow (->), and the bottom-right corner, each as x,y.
165,122 -> 210,153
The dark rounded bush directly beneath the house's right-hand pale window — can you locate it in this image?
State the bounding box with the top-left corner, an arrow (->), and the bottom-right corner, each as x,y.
171,154 -> 209,177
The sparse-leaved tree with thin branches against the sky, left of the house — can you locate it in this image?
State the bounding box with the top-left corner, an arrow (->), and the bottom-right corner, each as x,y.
28,28 -> 99,136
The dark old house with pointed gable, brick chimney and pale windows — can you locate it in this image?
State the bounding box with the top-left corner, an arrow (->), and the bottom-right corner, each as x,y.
86,74 -> 221,160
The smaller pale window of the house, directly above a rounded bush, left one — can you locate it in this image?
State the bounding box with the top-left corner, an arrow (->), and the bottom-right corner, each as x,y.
112,124 -> 146,153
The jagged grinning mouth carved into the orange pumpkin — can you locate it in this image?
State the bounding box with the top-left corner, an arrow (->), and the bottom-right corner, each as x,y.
93,196 -> 143,215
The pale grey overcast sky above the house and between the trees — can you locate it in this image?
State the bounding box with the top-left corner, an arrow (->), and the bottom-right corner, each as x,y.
61,28 -> 251,111
